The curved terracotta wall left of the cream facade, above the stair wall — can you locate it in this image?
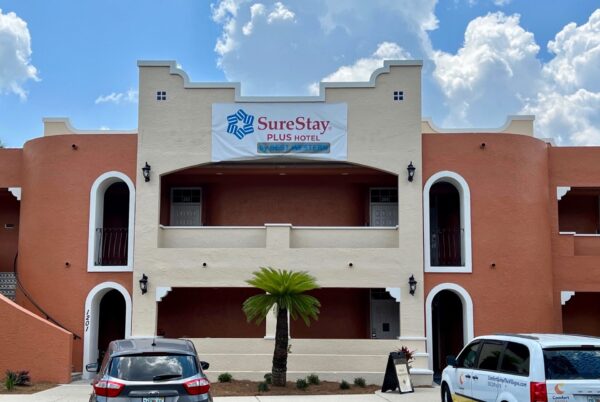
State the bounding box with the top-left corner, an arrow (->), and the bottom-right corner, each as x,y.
17,134 -> 137,371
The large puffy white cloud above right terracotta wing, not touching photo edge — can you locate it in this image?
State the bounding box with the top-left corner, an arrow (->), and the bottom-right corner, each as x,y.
433,12 -> 541,126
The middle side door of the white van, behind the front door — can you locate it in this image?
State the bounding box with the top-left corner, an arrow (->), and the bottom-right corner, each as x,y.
471,340 -> 505,402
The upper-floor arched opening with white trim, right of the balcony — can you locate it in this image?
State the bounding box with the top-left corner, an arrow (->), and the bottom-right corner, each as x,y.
423,171 -> 472,273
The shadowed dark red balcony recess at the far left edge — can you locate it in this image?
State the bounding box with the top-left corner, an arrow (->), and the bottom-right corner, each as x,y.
0,189 -> 20,272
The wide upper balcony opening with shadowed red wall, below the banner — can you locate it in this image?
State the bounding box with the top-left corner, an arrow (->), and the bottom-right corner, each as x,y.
159,161 -> 398,227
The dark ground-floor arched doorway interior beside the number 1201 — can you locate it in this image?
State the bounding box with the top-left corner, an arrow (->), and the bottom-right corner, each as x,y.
98,289 -> 125,361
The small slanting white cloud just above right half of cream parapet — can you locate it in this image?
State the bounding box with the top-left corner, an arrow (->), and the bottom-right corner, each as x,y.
309,42 -> 412,95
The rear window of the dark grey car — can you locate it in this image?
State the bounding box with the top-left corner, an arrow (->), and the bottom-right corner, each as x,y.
108,354 -> 198,381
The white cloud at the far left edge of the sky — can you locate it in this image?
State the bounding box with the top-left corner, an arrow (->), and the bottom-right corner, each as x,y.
0,9 -> 39,100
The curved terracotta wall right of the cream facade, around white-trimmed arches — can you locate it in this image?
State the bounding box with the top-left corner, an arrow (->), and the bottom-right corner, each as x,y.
423,134 -> 560,335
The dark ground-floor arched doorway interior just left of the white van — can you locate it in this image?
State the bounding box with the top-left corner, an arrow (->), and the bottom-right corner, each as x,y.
431,290 -> 464,375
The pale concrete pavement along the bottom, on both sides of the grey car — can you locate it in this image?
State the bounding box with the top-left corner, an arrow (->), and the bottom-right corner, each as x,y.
0,384 -> 440,402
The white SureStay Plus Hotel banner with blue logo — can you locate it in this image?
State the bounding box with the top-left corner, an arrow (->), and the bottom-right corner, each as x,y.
212,103 -> 348,162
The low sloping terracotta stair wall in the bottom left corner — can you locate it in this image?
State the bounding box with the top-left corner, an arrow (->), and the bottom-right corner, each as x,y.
0,295 -> 73,384
